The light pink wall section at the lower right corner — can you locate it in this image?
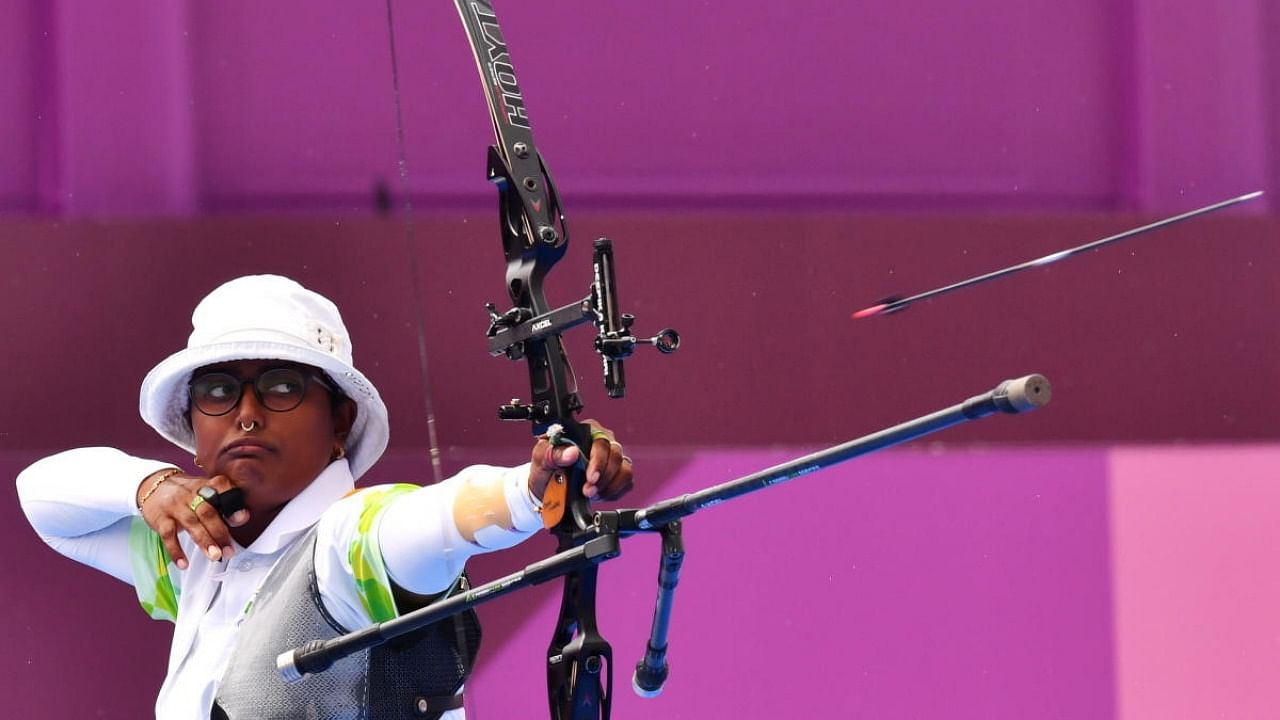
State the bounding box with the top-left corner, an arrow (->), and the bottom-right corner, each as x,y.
1108,446 -> 1280,720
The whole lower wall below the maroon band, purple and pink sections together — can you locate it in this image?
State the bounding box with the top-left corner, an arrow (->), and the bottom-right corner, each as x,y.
12,446 -> 1280,720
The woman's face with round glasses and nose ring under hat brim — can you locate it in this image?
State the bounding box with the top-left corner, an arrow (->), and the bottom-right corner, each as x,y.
191,360 -> 355,519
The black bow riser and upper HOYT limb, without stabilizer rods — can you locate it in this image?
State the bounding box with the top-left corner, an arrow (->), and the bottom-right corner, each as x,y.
454,0 -> 613,720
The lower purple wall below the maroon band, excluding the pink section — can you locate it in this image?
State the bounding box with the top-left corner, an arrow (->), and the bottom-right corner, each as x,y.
0,448 -> 1114,720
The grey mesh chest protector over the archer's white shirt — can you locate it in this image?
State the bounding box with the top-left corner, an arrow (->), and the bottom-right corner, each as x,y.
211,528 -> 480,720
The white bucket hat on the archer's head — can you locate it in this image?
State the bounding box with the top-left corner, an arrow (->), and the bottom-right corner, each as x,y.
138,275 -> 389,478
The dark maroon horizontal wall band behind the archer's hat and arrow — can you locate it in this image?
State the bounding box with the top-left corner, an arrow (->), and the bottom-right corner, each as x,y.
0,213 -> 1280,448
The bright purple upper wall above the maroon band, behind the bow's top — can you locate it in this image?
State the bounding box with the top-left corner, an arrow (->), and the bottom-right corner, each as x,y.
0,0 -> 1280,215
